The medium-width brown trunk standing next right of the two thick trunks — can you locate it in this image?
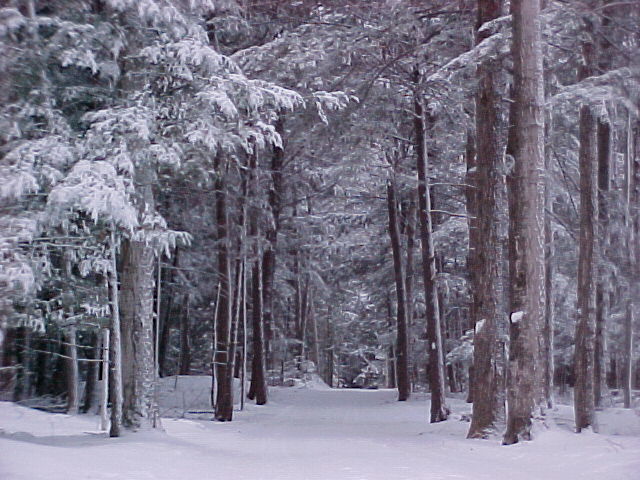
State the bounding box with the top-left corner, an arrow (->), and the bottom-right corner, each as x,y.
573,24 -> 598,432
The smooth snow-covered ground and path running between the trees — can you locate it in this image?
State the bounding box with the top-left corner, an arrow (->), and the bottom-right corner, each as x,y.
0,377 -> 640,480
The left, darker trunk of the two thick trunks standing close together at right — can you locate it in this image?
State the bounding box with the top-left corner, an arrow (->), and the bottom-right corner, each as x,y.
467,0 -> 505,438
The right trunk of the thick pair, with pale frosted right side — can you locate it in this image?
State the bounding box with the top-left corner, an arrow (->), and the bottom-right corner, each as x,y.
503,0 -> 545,444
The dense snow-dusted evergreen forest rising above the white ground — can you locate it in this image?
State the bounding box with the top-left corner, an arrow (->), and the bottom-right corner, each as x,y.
0,0 -> 640,450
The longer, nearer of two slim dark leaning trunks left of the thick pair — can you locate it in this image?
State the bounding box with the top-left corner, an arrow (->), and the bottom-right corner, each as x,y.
413,67 -> 449,423
